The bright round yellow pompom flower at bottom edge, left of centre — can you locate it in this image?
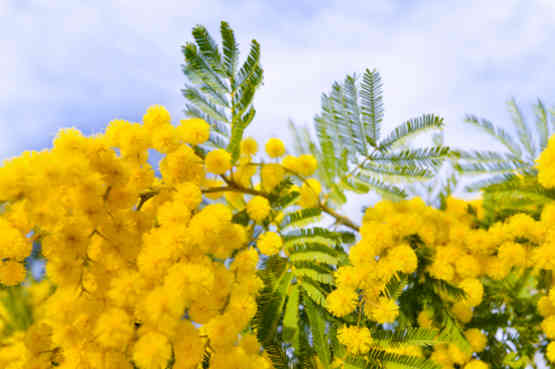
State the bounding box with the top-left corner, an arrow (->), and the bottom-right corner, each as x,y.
133,331 -> 172,369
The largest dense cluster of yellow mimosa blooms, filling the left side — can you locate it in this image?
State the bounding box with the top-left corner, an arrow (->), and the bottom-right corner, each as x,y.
0,105 -> 316,369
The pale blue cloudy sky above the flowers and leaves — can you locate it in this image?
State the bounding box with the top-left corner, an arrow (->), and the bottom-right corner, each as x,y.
0,0 -> 555,160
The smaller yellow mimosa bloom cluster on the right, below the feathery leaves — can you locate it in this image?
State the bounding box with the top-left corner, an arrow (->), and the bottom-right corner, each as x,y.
327,136 -> 555,369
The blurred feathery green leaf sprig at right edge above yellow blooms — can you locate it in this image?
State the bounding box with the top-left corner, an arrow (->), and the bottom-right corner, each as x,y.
456,99 -> 555,219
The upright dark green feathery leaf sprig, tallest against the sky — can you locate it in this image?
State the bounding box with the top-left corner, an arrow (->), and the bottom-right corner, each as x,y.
182,22 -> 264,162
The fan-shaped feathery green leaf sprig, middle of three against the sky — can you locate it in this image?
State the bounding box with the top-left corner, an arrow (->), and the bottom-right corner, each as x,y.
290,69 -> 450,204
